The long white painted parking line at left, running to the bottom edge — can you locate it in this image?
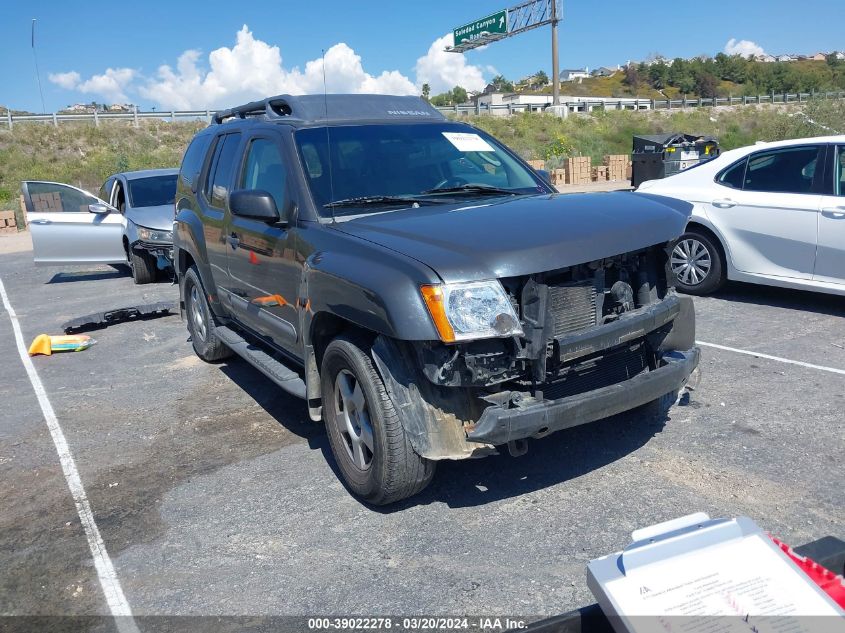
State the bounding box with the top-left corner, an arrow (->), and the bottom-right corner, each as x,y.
0,279 -> 140,633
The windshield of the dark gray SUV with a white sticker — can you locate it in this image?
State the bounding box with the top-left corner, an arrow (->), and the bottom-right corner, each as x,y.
296,123 -> 548,216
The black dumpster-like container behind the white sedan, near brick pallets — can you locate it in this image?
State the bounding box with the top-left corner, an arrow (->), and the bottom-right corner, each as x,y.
631,133 -> 719,188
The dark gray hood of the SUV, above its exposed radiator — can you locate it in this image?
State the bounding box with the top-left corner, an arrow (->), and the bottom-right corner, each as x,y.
333,192 -> 692,282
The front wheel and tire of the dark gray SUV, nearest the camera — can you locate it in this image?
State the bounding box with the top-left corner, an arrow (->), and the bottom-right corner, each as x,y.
320,336 -> 436,505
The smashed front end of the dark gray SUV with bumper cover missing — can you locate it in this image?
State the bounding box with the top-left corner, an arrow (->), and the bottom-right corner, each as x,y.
373,245 -> 699,459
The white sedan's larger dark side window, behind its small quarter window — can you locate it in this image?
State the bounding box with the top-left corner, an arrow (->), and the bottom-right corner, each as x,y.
742,145 -> 819,193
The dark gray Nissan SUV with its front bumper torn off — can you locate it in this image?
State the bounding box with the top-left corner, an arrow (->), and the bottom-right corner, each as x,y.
173,95 -> 699,504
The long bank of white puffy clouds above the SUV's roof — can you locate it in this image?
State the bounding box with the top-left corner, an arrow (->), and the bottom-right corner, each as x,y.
50,25 -> 495,110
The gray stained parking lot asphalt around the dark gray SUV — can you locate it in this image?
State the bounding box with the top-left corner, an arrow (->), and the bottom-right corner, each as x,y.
0,230 -> 845,618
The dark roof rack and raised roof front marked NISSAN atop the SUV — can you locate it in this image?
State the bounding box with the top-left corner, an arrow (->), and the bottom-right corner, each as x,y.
212,94 -> 445,124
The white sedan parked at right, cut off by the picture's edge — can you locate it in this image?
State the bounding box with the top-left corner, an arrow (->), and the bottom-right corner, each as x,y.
637,136 -> 845,295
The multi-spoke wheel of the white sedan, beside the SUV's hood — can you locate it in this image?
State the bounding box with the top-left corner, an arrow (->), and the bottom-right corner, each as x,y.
670,229 -> 726,296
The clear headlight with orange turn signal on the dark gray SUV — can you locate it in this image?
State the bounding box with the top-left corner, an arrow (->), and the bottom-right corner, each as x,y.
420,279 -> 522,343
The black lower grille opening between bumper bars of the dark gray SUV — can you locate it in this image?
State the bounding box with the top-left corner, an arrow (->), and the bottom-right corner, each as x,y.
542,342 -> 649,400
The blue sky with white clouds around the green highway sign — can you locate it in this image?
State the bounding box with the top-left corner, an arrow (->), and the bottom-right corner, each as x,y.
0,0 -> 845,112
